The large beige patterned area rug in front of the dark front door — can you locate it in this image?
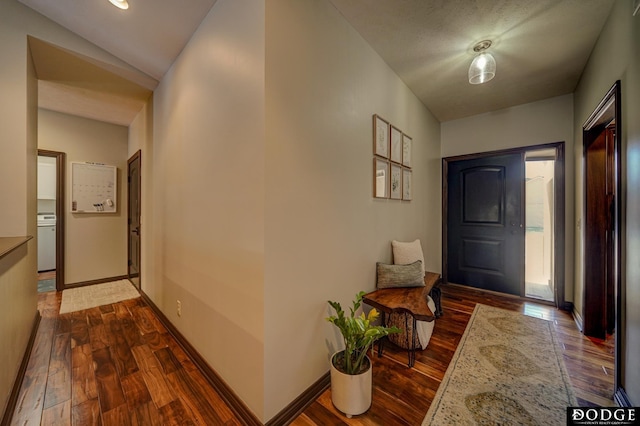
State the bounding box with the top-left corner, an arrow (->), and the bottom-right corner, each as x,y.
422,304 -> 577,426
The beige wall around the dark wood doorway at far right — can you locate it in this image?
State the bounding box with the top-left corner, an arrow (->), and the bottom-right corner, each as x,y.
574,0 -> 640,406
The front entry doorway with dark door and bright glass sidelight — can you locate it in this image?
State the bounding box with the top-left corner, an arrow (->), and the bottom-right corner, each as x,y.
442,142 -> 571,310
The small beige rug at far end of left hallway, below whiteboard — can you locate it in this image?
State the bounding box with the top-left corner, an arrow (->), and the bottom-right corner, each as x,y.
60,280 -> 140,314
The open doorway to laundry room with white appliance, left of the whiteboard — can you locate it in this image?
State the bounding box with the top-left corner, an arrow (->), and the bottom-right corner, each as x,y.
38,149 -> 66,291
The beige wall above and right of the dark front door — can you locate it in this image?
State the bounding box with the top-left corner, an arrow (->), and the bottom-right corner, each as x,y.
441,95 -> 576,301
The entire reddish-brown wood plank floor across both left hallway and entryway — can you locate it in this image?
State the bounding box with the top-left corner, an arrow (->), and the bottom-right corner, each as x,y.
7,285 -> 613,426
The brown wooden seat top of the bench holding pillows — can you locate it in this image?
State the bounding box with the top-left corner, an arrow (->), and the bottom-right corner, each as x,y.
362,272 -> 440,321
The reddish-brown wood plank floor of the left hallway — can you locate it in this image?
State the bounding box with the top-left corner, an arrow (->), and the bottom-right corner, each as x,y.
11,292 -> 242,426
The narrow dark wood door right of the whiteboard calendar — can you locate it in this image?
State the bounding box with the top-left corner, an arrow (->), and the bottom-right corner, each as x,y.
127,151 -> 141,288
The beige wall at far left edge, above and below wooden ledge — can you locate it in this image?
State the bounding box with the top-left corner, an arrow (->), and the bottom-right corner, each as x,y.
0,27 -> 38,410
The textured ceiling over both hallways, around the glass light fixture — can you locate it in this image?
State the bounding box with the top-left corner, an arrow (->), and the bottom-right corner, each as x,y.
19,0 -> 615,122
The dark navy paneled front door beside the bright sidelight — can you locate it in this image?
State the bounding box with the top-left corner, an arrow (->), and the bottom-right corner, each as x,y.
446,153 -> 524,295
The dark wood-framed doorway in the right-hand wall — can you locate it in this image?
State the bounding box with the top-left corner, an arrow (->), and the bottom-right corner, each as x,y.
582,81 -> 624,406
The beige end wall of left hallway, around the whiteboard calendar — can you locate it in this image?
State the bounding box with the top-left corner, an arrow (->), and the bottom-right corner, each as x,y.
38,109 -> 128,284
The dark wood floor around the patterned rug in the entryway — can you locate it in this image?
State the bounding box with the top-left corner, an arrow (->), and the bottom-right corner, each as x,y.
292,284 -> 615,426
